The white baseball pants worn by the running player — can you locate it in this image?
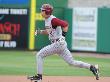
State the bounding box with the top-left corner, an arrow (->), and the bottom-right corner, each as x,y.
36,40 -> 91,74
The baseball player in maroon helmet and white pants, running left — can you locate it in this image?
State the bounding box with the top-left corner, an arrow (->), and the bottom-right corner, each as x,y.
29,4 -> 99,82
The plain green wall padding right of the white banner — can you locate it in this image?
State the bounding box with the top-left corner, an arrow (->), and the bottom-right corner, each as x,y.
97,8 -> 110,53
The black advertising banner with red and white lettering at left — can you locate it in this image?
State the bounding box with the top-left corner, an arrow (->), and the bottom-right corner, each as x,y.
0,8 -> 29,49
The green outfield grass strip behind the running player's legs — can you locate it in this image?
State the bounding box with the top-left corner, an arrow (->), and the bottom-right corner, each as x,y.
0,51 -> 110,76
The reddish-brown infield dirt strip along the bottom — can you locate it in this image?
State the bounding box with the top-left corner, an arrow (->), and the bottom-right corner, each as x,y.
0,76 -> 110,82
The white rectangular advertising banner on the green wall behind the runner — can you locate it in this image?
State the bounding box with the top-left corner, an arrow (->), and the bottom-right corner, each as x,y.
72,8 -> 97,51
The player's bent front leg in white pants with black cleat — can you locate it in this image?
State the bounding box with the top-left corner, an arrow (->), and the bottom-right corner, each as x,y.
30,43 -> 59,81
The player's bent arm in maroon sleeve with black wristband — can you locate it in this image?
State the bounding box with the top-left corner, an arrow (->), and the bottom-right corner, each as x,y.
51,18 -> 69,37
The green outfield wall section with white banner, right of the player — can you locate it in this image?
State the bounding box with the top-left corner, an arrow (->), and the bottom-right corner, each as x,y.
65,7 -> 110,53
